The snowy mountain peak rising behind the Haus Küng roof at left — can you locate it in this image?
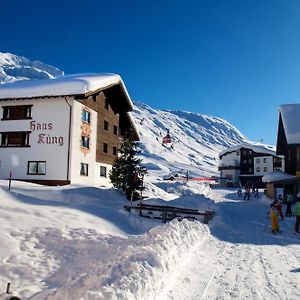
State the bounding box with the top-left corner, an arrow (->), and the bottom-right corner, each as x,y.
0,52 -> 64,83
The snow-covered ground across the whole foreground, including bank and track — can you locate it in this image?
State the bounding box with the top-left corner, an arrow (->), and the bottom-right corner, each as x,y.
0,181 -> 300,300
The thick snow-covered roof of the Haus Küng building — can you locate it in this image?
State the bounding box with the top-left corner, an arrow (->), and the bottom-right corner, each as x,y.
0,73 -> 132,106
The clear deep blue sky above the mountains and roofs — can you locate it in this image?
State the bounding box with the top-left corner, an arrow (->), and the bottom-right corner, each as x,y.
0,0 -> 300,144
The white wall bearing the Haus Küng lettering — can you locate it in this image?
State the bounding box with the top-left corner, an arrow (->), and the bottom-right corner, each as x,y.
0,98 -> 69,180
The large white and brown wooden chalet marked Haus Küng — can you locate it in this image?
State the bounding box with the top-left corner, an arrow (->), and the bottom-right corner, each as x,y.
0,74 -> 138,185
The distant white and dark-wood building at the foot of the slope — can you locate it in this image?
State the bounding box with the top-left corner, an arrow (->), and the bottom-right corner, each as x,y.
219,143 -> 282,187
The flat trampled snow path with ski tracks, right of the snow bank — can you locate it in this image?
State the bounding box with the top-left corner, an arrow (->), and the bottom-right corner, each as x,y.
161,197 -> 300,300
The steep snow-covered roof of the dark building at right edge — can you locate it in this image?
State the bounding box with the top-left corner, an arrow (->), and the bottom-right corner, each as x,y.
279,104 -> 300,144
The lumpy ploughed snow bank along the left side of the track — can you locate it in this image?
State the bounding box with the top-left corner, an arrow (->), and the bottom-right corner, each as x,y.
32,220 -> 208,300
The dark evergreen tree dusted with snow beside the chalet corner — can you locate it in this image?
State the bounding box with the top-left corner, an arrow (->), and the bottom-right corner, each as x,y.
109,139 -> 147,199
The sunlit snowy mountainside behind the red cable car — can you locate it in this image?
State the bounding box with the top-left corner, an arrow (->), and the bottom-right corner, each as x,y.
133,103 -> 247,177
